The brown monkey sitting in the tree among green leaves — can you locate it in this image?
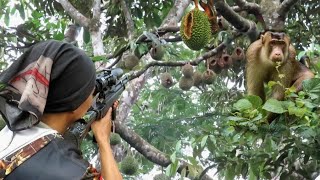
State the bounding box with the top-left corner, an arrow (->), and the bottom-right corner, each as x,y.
246,31 -> 314,102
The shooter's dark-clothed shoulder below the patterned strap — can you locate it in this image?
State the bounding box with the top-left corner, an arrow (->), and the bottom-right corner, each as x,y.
7,138 -> 89,180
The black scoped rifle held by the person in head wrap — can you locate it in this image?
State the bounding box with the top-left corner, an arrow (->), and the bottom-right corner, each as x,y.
69,68 -> 129,145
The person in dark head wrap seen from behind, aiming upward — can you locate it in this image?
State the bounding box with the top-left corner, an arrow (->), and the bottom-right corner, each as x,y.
0,40 -> 124,180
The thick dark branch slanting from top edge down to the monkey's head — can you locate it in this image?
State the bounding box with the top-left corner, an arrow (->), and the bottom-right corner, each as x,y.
215,0 -> 259,41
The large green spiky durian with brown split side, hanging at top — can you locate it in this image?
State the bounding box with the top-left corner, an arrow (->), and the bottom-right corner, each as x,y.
180,7 -> 211,51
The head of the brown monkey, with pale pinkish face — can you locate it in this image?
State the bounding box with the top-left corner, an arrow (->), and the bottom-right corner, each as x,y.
261,31 -> 290,64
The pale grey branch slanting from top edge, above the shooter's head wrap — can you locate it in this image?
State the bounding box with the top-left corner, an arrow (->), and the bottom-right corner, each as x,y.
57,0 -> 90,27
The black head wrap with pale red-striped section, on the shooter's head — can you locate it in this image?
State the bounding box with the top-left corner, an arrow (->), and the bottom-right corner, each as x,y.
0,40 -> 95,131
